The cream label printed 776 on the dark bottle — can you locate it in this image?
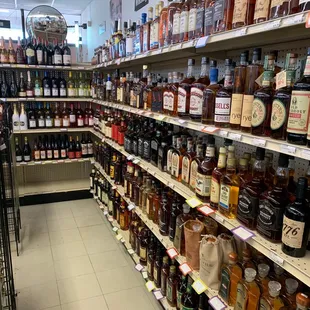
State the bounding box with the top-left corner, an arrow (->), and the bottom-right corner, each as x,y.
282,215 -> 305,249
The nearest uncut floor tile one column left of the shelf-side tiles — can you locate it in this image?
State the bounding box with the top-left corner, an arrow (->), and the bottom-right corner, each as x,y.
58,274 -> 102,304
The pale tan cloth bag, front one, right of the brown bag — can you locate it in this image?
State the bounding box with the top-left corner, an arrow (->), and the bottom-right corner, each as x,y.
199,235 -> 223,290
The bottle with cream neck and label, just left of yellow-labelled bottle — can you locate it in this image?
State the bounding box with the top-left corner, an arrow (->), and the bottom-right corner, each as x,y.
210,147 -> 226,210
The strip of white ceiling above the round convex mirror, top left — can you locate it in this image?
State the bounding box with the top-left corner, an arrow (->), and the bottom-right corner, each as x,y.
0,0 -> 92,16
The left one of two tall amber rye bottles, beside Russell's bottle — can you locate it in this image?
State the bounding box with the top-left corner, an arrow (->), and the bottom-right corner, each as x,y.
230,52 -> 248,130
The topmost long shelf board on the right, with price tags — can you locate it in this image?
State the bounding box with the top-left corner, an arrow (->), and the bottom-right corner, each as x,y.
90,12 -> 309,70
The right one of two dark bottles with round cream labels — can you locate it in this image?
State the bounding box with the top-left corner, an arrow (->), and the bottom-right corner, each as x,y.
270,53 -> 297,140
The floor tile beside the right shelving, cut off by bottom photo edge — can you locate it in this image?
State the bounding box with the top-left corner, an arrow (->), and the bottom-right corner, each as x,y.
104,287 -> 154,310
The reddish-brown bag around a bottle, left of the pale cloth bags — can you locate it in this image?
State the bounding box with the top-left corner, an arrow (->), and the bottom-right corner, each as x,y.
184,220 -> 204,270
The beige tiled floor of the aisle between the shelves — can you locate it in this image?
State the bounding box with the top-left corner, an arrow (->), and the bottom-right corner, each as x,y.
12,199 -> 161,310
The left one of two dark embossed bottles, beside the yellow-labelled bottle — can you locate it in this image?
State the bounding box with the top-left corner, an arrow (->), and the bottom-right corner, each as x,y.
237,147 -> 266,229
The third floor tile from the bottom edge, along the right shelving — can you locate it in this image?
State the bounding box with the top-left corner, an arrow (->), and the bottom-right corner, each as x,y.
89,250 -> 128,272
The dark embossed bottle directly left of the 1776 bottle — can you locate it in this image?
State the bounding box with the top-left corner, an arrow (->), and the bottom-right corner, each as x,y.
256,154 -> 289,242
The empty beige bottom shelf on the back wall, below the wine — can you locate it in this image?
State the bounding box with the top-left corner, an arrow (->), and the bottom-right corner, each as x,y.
19,179 -> 89,197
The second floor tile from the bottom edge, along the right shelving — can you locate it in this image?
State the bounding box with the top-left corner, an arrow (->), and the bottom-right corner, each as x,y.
96,266 -> 142,294
